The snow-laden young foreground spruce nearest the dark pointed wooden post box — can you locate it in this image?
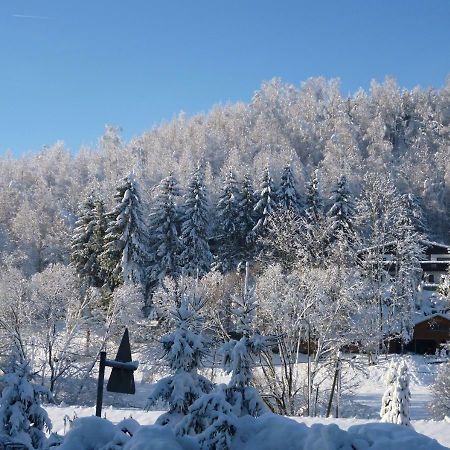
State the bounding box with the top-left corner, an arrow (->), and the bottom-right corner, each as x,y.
148,292 -> 213,426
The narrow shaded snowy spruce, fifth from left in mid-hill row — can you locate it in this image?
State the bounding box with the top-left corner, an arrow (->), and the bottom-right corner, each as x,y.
216,169 -> 241,272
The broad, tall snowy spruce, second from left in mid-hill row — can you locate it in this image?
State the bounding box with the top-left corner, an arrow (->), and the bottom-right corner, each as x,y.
101,175 -> 151,289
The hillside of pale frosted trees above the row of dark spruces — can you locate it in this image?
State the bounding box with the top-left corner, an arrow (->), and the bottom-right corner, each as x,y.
0,78 -> 450,275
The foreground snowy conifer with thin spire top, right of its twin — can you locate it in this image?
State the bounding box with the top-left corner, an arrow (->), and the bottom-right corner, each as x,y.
222,263 -> 275,417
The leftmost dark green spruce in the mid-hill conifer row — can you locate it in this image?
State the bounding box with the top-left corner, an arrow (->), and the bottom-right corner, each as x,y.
70,194 -> 106,287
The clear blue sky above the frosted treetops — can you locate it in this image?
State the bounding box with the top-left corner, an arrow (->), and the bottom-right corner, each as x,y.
0,0 -> 450,155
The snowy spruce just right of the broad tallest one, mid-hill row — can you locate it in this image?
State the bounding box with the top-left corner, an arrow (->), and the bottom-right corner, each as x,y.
149,173 -> 182,288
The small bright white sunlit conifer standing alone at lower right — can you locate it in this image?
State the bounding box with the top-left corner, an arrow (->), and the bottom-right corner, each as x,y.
380,361 -> 411,426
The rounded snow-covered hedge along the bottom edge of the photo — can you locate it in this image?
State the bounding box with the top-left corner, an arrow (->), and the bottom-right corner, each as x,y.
59,413 -> 445,450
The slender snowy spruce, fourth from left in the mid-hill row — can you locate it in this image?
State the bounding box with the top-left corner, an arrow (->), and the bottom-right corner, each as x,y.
181,166 -> 212,277
